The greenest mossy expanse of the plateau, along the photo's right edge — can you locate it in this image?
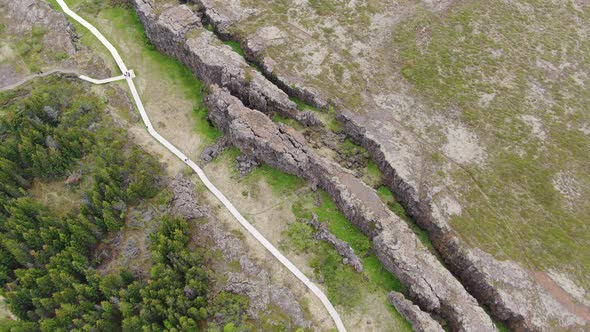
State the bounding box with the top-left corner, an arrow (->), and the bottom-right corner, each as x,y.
391,0 -> 590,288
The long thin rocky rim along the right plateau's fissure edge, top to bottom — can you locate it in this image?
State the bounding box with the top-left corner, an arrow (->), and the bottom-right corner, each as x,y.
193,0 -> 587,331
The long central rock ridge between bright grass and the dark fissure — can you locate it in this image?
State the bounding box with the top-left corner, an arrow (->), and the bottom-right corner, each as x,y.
205,86 -> 495,331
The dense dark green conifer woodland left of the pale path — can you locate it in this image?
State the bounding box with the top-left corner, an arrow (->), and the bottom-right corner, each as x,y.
0,79 -> 298,331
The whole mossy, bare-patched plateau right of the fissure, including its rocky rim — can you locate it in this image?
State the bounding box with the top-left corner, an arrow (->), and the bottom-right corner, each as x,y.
182,0 -> 590,328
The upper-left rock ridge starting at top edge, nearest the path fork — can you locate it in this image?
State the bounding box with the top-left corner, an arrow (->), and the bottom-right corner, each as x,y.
132,0 -> 317,125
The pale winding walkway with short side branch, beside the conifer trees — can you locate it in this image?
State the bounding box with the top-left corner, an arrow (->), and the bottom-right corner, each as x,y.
57,0 -> 346,332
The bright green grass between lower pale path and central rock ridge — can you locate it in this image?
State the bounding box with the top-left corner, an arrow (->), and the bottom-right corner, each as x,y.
243,165 -> 411,331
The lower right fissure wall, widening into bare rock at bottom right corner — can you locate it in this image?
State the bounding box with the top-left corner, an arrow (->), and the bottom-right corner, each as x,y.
339,110 -> 585,331
